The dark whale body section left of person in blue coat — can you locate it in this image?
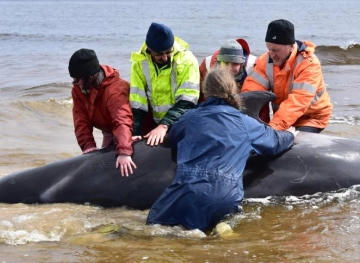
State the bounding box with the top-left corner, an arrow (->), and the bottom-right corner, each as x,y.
0,141 -> 176,209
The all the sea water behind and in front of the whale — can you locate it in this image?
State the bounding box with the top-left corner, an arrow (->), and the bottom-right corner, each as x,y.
0,0 -> 360,263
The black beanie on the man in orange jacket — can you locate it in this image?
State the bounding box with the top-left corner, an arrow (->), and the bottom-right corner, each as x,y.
265,19 -> 295,45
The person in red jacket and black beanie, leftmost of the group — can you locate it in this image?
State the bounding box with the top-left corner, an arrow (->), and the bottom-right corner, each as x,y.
69,48 -> 136,176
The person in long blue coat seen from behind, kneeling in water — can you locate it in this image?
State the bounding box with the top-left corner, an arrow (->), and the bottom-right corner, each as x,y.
147,67 -> 297,231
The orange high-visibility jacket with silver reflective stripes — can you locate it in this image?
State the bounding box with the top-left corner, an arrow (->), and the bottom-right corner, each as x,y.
241,41 -> 333,130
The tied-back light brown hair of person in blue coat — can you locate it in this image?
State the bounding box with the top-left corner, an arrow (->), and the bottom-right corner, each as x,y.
203,66 -> 241,109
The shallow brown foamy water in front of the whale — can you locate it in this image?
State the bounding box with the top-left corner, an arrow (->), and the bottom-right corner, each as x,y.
0,192 -> 360,262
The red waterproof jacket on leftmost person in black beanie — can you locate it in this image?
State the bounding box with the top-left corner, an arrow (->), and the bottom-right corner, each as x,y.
71,65 -> 133,155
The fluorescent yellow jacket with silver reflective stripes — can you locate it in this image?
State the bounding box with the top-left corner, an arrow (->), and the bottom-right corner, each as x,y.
130,37 -> 200,123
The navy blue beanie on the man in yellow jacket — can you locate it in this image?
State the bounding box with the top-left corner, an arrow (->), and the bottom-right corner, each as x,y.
145,22 -> 174,51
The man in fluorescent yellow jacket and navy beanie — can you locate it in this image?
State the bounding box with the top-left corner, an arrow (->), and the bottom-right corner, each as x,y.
129,23 -> 200,146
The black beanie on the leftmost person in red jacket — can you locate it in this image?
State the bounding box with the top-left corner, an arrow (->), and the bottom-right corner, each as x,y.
69,48 -> 100,79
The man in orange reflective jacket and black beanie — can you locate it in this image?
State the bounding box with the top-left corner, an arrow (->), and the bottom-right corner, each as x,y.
241,19 -> 333,133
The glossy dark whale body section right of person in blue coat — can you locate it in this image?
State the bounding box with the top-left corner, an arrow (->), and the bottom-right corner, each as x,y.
244,132 -> 360,198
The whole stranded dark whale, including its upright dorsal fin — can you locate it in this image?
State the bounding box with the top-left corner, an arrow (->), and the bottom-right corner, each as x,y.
0,92 -> 360,209
